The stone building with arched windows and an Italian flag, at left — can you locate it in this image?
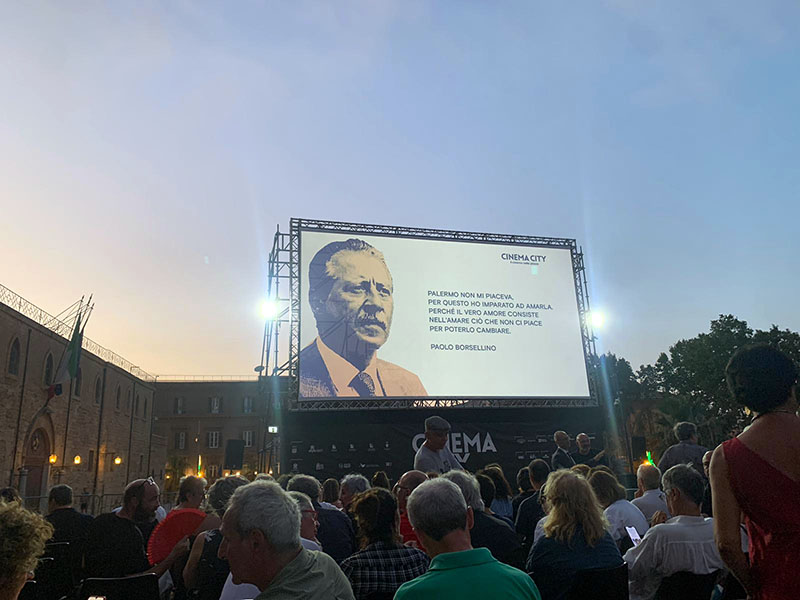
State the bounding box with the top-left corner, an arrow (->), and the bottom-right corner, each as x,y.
0,286 -> 166,512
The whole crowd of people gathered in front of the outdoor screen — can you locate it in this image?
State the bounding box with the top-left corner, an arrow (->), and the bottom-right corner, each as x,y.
0,346 -> 800,600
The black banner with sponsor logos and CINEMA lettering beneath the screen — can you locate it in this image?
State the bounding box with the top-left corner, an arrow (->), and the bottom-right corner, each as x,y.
282,409 -> 602,487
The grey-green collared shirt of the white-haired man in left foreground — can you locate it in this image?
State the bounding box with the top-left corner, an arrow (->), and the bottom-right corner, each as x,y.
256,548 -> 353,600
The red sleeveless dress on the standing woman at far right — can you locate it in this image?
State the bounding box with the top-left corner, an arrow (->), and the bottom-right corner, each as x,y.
722,438 -> 800,600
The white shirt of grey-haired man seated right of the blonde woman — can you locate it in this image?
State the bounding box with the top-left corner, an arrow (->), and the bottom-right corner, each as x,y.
623,515 -> 725,600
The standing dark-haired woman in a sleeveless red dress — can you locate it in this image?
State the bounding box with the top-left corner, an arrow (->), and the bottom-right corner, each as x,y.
710,345 -> 800,600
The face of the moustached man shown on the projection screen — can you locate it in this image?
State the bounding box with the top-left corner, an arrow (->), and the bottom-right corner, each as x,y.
325,250 -> 394,348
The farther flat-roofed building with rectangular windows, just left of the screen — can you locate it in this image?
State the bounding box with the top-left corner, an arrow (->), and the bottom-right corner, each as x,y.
155,377 -> 275,490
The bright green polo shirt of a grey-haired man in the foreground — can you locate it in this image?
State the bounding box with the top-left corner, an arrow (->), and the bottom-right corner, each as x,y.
394,548 -> 541,600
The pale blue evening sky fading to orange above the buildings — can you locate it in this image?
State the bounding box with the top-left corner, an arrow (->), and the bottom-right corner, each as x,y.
0,0 -> 800,374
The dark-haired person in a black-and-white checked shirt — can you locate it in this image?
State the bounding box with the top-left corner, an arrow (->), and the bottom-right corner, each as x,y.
341,487 -> 430,600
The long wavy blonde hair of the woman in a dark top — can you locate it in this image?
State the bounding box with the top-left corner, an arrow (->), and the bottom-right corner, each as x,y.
544,469 -> 608,546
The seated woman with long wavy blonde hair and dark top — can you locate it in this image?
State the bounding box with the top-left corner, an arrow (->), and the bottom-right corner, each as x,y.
526,469 -> 622,600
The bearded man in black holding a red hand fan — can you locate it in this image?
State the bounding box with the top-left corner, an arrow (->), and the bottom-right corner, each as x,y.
83,478 -> 189,577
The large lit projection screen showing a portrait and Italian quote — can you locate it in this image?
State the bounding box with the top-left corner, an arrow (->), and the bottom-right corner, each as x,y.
298,229 -> 590,399
